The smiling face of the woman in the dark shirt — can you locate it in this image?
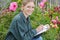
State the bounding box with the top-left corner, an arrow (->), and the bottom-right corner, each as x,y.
23,2 -> 35,16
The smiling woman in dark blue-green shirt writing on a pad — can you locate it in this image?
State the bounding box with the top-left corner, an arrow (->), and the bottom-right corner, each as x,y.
5,0 -> 48,40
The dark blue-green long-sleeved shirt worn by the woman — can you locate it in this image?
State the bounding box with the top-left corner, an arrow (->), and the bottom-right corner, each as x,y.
5,12 -> 37,40
